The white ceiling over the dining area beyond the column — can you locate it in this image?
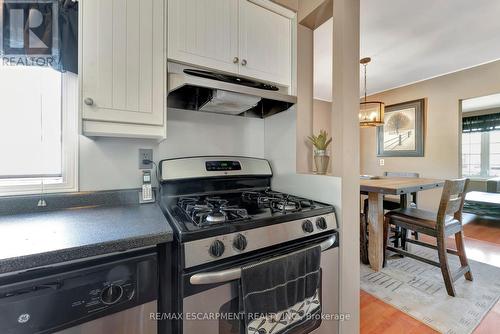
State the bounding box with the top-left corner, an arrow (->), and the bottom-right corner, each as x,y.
314,0 -> 500,101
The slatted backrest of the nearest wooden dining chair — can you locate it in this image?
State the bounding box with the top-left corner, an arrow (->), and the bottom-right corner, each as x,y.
437,179 -> 469,227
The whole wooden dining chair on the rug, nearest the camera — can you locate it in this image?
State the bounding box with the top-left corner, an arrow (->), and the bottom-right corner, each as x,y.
384,179 -> 472,296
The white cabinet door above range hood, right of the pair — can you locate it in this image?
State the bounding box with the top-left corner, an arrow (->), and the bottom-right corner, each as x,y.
239,0 -> 292,86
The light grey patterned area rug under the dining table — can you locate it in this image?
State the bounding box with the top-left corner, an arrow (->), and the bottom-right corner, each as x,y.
361,245 -> 500,334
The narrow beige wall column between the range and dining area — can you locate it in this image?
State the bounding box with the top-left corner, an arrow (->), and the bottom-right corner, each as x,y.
331,0 -> 360,334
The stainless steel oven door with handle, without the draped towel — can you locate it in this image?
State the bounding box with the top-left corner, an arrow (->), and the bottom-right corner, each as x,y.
181,232 -> 339,334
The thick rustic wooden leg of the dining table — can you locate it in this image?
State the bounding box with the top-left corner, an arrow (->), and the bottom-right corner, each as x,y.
368,193 -> 385,271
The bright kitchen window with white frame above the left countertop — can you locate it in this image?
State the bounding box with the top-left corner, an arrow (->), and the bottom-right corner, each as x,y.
0,65 -> 78,195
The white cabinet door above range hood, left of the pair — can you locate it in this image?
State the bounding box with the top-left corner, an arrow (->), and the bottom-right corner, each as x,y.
168,0 -> 238,73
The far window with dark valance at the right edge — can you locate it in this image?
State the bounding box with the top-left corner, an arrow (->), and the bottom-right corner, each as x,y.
462,130 -> 500,178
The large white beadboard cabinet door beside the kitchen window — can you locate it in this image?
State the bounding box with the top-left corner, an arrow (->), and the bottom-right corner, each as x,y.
80,0 -> 166,125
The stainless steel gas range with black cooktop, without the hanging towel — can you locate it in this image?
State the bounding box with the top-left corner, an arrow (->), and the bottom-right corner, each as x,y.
160,156 -> 339,334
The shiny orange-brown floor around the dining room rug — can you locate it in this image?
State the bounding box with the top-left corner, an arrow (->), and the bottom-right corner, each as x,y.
360,221 -> 500,334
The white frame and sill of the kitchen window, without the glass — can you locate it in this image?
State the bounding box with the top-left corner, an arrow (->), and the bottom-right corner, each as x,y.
0,72 -> 79,196
